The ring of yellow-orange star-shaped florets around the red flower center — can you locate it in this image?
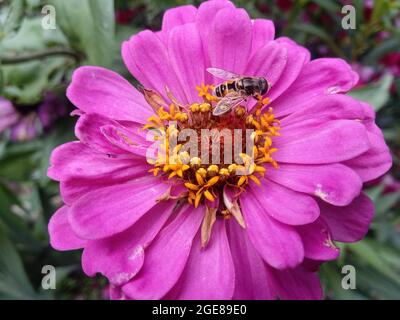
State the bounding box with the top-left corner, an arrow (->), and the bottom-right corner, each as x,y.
142,84 -> 280,209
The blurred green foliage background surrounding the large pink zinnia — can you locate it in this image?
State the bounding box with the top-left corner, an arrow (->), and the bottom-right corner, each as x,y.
0,0 -> 400,299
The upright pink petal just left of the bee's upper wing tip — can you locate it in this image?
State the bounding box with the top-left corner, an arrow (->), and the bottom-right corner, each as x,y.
168,23 -> 206,102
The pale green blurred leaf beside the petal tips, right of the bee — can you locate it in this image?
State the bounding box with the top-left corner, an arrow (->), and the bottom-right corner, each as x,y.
348,74 -> 393,111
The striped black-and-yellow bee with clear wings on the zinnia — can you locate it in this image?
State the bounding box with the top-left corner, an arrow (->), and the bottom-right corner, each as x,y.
207,68 -> 271,116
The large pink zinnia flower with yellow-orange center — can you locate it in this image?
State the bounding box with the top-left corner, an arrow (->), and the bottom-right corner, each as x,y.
48,0 -> 392,299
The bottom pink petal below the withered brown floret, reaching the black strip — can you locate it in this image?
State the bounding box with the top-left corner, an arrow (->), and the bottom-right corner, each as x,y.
168,219 -> 235,300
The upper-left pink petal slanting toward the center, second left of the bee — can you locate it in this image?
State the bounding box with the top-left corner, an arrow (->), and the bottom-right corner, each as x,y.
122,30 -> 189,103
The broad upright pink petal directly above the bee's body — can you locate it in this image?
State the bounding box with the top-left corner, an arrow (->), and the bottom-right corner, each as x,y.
208,8 -> 252,77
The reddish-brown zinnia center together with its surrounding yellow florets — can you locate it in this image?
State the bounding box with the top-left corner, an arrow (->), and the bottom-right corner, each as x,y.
143,84 -> 280,207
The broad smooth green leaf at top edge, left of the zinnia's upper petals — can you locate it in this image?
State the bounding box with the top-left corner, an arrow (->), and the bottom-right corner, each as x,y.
51,0 -> 115,67
